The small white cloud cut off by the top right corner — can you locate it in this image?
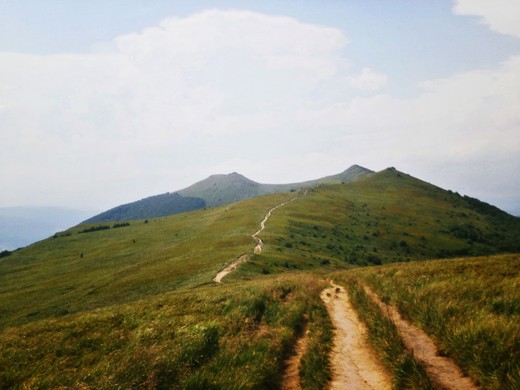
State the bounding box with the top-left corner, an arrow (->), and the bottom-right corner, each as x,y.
454,0 -> 520,38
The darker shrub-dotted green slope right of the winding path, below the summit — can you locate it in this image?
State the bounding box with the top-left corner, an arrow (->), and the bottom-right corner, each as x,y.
238,168 -> 520,272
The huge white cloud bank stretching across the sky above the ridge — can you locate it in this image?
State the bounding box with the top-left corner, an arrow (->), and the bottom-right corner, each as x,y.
0,3 -> 520,213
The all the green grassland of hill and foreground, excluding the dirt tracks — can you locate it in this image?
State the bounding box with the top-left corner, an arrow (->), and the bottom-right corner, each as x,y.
0,169 -> 520,389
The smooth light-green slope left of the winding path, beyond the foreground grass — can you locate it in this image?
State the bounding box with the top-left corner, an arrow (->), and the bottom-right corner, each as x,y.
0,194 -> 288,328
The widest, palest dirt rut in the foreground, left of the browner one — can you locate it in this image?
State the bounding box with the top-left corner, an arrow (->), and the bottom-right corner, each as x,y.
321,282 -> 391,390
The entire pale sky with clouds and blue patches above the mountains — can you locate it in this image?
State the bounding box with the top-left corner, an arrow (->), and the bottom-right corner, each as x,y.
0,0 -> 520,215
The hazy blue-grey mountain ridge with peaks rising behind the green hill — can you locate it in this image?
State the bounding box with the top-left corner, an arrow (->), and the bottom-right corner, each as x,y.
83,165 -> 373,224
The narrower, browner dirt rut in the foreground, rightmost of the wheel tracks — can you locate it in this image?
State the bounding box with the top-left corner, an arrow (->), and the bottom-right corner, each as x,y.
364,286 -> 478,390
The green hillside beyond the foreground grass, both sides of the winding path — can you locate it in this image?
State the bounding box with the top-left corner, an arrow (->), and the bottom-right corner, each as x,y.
0,169 -> 520,326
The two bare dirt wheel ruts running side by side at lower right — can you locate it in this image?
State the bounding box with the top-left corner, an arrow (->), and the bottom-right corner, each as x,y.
321,283 -> 478,390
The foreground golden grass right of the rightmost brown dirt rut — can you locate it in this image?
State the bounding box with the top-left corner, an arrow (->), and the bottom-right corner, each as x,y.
342,254 -> 520,389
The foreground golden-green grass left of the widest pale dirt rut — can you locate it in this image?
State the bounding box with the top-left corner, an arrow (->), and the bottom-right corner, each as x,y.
0,276 -> 330,389
